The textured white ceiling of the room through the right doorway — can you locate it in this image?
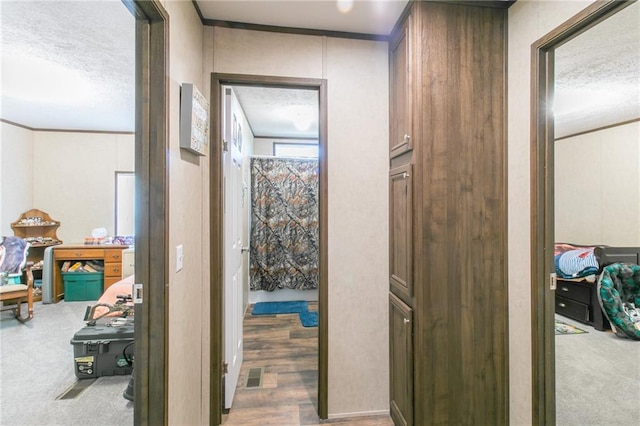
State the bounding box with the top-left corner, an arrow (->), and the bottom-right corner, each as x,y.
553,3 -> 640,137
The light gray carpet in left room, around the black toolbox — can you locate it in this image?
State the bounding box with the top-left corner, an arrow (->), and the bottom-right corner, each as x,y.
0,301 -> 133,426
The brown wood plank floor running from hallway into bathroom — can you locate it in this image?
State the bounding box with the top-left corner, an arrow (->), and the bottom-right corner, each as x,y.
222,302 -> 393,426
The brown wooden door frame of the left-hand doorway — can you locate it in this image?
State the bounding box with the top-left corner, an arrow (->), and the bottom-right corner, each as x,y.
122,0 -> 169,425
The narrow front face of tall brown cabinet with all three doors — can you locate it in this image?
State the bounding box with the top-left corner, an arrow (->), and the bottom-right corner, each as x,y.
389,9 -> 415,426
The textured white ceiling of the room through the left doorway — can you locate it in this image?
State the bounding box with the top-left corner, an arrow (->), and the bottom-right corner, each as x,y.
0,0 -> 135,131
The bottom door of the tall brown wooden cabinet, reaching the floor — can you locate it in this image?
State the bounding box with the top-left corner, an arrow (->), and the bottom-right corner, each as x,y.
389,294 -> 413,426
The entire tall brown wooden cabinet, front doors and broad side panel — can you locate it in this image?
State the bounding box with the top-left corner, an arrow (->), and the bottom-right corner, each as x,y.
389,1 -> 509,425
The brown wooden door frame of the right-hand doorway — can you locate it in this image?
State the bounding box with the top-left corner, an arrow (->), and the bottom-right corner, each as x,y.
531,0 -> 636,426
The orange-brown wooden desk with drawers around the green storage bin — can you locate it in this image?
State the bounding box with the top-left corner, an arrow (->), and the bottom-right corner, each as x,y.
52,244 -> 129,303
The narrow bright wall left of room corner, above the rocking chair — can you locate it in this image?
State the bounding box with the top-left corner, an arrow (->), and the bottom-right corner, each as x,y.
0,121 -> 33,235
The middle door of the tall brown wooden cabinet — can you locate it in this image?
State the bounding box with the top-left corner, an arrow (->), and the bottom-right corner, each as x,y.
389,164 -> 413,304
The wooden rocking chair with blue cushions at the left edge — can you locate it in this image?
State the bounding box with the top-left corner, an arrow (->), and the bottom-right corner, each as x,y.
0,237 -> 33,323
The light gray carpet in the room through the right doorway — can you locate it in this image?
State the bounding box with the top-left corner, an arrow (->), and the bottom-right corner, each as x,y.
555,315 -> 640,426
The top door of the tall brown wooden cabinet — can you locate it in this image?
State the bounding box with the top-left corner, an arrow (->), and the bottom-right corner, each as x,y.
389,11 -> 413,158
